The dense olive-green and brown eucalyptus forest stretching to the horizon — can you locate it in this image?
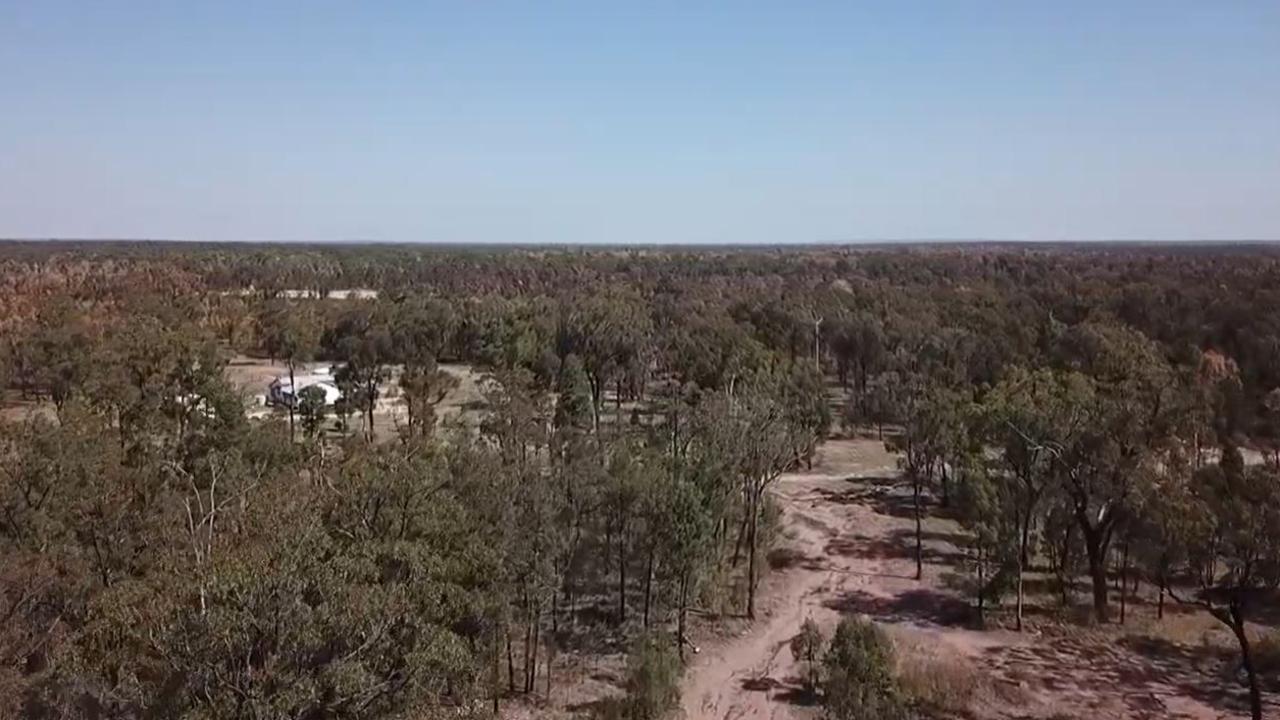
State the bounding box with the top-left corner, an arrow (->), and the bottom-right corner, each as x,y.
0,242 -> 1280,720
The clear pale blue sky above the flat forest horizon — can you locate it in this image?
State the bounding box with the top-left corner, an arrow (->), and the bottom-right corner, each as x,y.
0,0 -> 1280,242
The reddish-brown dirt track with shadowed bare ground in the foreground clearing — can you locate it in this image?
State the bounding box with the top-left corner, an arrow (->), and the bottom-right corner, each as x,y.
682,430 -> 1276,720
